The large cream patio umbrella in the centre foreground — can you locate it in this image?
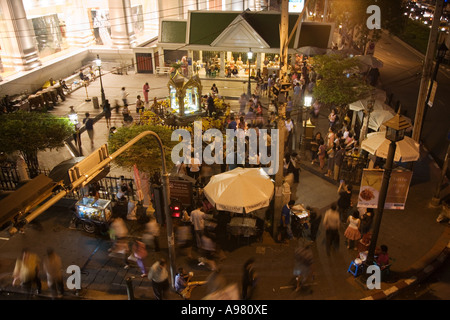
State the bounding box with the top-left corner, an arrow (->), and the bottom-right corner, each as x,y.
203,167 -> 274,213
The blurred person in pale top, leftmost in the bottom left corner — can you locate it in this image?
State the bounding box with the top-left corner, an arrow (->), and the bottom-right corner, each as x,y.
13,248 -> 42,294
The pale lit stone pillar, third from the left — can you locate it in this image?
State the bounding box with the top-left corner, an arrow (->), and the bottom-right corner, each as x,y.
108,0 -> 137,49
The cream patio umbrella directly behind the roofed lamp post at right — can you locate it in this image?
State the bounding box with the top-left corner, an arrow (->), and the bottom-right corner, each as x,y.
361,132 -> 420,162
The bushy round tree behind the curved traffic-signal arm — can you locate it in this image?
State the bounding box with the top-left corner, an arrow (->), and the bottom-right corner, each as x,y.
108,125 -> 178,173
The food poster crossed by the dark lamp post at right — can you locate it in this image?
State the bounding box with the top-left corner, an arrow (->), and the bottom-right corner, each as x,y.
358,169 -> 412,210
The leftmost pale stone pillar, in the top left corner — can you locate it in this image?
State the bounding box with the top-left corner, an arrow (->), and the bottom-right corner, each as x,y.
0,0 -> 42,70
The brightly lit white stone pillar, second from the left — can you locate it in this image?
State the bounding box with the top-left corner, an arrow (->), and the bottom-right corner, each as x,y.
64,0 -> 95,48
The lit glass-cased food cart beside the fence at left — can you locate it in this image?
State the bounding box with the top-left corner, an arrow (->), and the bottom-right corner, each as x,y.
75,197 -> 112,233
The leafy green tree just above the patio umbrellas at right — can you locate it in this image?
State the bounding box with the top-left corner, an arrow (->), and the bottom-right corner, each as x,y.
313,55 -> 369,107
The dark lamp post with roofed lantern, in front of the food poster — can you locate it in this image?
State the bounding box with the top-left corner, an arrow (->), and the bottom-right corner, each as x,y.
366,113 -> 411,266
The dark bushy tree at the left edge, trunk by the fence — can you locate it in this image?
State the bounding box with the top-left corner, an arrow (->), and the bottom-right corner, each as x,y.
0,111 -> 74,178
